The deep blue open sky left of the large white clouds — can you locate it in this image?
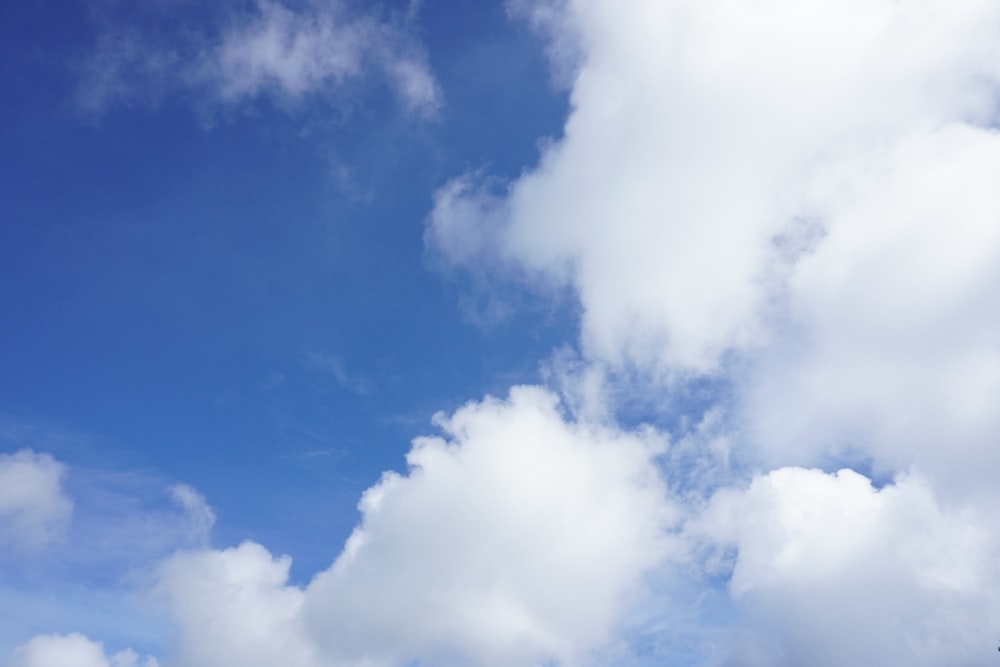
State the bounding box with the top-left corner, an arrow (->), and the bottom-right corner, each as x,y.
0,3 -> 568,574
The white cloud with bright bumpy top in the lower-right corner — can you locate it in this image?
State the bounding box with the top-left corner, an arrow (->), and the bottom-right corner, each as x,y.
698,468 -> 1000,667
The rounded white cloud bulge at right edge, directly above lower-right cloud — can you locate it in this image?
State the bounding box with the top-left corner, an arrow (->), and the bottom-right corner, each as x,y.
745,124 -> 1000,490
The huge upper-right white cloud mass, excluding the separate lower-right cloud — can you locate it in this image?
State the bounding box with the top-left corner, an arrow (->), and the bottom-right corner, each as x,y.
427,0 -> 1000,486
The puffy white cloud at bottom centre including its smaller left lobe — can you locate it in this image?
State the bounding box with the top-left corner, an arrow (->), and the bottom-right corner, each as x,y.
148,387 -> 678,667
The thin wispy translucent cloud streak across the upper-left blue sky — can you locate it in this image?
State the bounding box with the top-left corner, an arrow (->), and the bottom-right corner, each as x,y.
78,0 -> 440,116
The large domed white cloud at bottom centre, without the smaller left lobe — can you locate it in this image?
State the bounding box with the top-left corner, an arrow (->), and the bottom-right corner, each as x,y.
307,388 -> 671,665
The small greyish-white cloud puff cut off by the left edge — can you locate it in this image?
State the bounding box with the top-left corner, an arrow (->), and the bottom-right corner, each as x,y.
0,449 -> 73,549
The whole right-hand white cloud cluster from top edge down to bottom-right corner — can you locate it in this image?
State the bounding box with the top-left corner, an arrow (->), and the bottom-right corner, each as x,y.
427,0 -> 1000,665
